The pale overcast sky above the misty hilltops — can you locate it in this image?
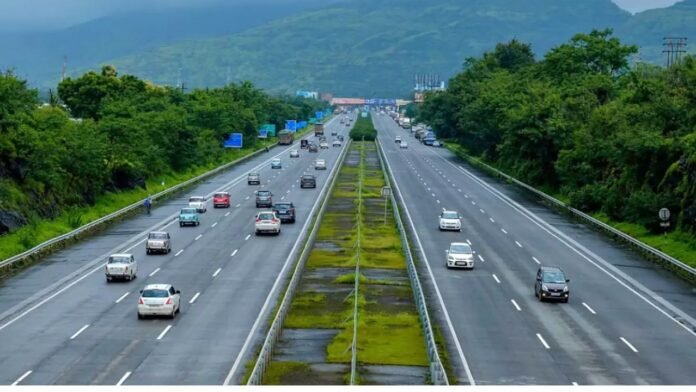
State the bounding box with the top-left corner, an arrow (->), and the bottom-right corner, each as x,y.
0,0 -> 678,30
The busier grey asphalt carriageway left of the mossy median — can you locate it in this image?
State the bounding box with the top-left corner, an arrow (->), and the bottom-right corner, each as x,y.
0,115 -> 349,385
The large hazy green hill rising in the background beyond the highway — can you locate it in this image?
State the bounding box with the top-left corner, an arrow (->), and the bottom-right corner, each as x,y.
110,0 -> 631,96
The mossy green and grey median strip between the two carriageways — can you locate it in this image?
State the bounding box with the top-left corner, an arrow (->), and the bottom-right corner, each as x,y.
263,142 -> 429,385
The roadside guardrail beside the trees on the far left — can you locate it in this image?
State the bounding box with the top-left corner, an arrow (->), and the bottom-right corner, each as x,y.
0,143 -> 277,268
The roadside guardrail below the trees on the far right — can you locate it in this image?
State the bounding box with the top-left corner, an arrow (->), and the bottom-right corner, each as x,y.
456,152 -> 696,279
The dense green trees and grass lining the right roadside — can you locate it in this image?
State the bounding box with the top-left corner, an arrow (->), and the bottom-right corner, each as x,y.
419,30 -> 696,266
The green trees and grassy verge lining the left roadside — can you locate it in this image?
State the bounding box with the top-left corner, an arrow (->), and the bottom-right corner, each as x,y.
0,66 -> 322,260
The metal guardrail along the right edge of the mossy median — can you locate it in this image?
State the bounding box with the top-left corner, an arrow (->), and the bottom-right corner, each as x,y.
375,138 -> 449,385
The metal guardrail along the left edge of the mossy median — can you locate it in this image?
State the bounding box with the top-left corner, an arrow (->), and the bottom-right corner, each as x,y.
247,138 -> 351,385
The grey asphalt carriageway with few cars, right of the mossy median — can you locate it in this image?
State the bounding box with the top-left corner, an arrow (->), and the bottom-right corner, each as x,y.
373,115 -> 696,385
